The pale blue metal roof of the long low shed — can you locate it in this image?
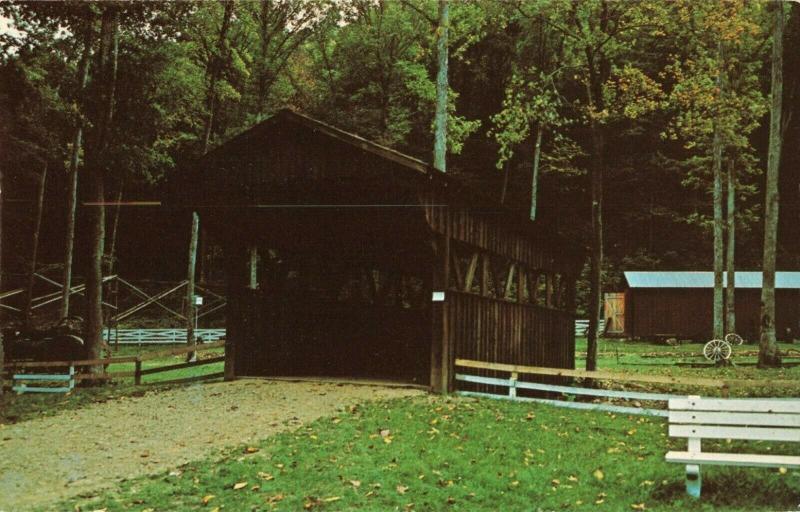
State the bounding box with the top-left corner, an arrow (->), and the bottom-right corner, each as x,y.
625,271 -> 800,289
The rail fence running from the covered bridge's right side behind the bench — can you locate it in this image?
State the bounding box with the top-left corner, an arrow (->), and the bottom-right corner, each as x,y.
455,359 -> 797,417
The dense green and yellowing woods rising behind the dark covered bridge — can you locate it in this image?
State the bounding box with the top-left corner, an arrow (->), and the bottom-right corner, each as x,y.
0,0 -> 800,368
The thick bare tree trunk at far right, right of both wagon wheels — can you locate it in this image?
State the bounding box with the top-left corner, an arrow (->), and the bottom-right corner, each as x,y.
758,2 -> 784,368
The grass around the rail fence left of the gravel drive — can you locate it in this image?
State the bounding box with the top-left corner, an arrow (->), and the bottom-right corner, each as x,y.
0,345 -> 224,424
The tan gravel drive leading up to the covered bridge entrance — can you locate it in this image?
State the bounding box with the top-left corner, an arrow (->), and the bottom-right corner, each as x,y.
0,379 -> 422,512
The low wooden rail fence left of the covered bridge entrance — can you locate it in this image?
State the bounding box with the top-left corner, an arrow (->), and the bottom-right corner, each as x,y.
3,340 -> 225,392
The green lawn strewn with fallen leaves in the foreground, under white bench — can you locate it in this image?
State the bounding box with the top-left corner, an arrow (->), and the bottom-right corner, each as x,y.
62,398 -> 800,512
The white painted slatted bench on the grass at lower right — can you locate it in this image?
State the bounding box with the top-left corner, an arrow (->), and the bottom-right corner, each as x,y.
666,396 -> 800,498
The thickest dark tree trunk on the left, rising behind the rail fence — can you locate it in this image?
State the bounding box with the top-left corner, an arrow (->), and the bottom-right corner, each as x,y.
85,4 -> 119,373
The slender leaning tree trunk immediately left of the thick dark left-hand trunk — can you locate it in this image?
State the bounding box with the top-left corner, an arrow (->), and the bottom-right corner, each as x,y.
59,19 -> 94,318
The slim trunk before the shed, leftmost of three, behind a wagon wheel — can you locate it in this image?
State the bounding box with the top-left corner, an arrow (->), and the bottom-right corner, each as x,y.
711,43 -> 725,340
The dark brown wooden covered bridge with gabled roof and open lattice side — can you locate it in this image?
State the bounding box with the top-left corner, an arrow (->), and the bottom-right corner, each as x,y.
173,110 -> 583,392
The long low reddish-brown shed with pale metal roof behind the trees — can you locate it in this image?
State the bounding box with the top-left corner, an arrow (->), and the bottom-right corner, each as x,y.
606,272 -> 800,341
